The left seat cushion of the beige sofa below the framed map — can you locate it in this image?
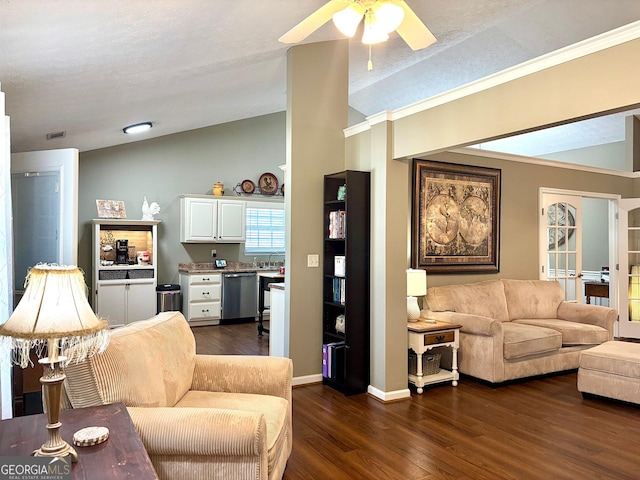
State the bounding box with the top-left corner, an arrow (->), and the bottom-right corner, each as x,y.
502,322 -> 562,360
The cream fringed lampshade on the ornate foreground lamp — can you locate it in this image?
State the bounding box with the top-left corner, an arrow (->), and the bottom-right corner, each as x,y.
0,264 -> 109,368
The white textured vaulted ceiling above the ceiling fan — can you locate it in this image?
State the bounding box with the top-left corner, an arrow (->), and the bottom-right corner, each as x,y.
0,0 -> 640,156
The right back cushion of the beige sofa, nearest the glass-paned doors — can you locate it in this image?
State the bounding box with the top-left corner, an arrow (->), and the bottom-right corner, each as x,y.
502,280 -> 564,320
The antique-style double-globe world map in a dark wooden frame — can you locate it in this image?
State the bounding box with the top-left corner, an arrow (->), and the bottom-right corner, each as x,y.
411,160 -> 501,273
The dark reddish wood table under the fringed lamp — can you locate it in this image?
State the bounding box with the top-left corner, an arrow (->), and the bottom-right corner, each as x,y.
0,403 -> 158,480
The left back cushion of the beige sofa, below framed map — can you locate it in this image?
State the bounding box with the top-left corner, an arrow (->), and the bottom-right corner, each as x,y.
427,280 -> 509,322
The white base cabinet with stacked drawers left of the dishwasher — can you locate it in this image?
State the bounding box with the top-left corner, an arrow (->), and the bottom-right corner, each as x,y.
180,272 -> 222,326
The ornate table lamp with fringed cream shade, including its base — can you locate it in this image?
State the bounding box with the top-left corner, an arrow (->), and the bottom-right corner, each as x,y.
0,264 -> 109,462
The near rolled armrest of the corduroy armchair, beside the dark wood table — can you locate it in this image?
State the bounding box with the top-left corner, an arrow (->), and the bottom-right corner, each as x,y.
127,407 -> 267,456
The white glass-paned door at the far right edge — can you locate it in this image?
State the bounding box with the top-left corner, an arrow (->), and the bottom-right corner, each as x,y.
618,198 -> 640,338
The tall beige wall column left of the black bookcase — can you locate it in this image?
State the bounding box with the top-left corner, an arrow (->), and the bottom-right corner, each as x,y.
285,40 -> 349,377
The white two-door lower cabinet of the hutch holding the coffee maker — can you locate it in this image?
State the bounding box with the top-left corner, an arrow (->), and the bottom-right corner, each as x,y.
95,280 -> 156,327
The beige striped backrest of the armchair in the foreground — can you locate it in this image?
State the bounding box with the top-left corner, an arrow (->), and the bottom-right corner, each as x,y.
65,312 -> 196,408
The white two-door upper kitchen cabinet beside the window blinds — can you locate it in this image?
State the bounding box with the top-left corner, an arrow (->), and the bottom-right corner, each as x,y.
180,195 -> 247,243
